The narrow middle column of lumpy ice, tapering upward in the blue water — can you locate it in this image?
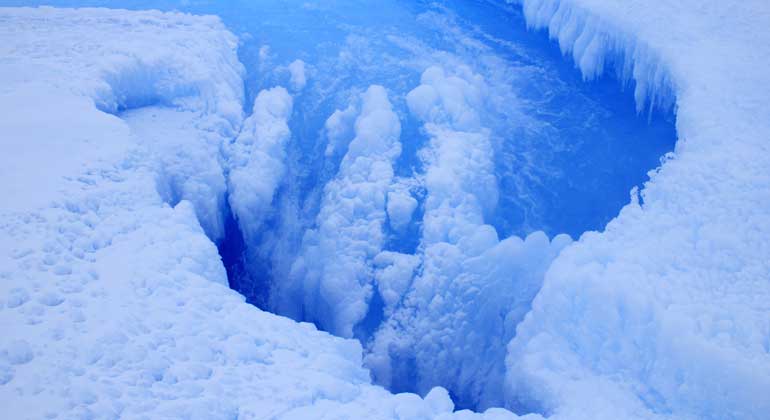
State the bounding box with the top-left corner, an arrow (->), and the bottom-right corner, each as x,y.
290,86 -> 401,337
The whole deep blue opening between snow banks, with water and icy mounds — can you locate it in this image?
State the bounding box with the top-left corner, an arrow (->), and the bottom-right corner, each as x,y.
6,0 -> 676,409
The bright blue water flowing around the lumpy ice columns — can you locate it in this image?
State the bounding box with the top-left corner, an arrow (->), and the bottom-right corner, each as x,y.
7,0 -> 675,406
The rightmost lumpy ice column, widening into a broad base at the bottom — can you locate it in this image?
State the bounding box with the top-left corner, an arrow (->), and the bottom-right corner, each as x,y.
366,67 -> 570,408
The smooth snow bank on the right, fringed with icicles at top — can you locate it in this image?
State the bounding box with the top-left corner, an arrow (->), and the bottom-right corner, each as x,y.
500,0 -> 770,419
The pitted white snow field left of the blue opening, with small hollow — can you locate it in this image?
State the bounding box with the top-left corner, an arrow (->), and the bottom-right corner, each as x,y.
0,8 -> 514,419
